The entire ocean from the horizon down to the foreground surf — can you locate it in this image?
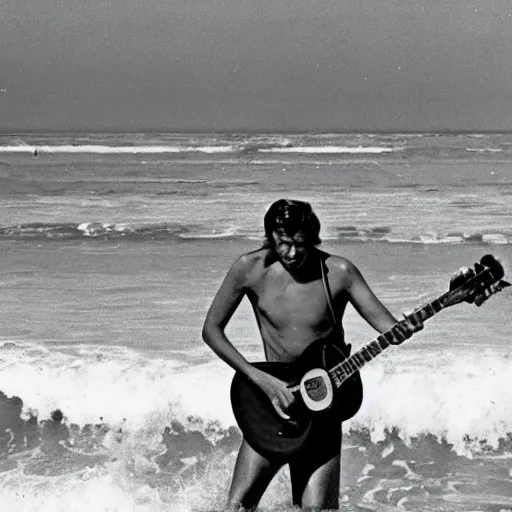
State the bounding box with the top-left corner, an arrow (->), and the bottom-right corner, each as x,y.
0,134 -> 512,512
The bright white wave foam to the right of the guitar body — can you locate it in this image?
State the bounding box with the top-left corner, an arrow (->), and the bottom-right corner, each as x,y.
351,349 -> 512,454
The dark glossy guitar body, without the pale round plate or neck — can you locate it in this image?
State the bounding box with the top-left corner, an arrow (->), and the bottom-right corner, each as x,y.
231,340 -> 363,461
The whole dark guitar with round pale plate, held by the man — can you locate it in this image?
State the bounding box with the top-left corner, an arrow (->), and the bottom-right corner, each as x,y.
231,254 -> 510,461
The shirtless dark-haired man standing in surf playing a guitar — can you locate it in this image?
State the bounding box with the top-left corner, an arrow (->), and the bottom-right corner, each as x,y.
203,199 -> 423,510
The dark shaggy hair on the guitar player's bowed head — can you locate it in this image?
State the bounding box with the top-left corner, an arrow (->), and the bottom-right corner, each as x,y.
263,199 -> 322,247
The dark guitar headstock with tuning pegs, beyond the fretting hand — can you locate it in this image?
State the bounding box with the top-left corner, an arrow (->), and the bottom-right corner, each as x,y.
443,254 -> 510,307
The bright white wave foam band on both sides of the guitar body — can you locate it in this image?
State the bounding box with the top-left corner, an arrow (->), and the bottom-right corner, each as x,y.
0,340 -> 512,449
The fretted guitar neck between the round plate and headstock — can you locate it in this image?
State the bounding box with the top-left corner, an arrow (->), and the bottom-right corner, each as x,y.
328,292 -> 450,388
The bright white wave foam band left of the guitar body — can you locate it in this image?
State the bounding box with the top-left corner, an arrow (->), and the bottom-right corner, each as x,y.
0,346 -> 233,430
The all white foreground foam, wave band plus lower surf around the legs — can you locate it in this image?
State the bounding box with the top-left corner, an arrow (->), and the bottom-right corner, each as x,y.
0,343 -> 512,512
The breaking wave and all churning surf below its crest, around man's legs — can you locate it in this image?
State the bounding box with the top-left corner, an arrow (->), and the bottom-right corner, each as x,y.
0,342 -> 512,512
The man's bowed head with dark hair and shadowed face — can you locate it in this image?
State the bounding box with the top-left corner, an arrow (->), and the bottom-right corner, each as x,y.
264,199 -> 320,269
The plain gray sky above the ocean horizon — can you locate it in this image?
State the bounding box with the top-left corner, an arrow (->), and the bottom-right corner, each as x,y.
0,0 -> 512,131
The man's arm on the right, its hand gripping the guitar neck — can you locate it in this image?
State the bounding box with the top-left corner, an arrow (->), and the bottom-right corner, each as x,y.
345,262 -> 423,340
